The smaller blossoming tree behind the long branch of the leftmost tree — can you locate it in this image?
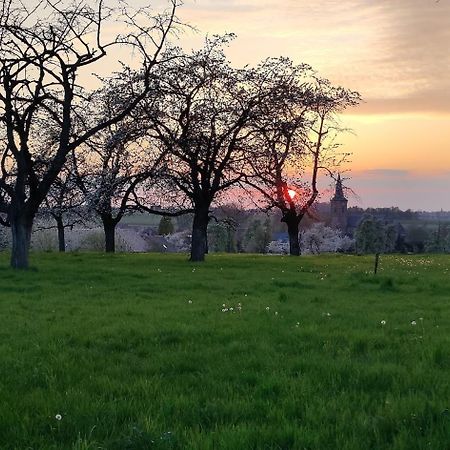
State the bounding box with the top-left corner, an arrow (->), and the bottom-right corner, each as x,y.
75,77 -> 170,252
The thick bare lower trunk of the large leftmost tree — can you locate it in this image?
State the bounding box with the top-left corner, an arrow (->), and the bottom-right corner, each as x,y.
10,213 -> 33,269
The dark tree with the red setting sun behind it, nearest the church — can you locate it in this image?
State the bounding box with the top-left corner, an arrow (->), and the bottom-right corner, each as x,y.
245,64 -> 360,255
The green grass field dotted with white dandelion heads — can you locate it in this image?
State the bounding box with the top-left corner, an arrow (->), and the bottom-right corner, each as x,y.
0,253 -> 450,450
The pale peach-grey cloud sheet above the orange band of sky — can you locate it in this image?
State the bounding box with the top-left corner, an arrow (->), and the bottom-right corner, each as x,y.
178,0 -> 450,114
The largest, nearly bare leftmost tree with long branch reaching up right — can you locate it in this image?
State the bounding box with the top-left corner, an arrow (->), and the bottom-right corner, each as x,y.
0,0 -> 177,268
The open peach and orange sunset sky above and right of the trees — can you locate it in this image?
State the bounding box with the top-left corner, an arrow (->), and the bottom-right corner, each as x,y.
172,0 -> 450,210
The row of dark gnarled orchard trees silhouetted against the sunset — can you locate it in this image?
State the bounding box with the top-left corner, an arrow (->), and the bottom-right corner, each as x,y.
0,0 -> 360,268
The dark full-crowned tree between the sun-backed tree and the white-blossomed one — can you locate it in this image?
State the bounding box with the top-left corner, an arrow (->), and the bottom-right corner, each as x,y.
137,35 -> 260,261
